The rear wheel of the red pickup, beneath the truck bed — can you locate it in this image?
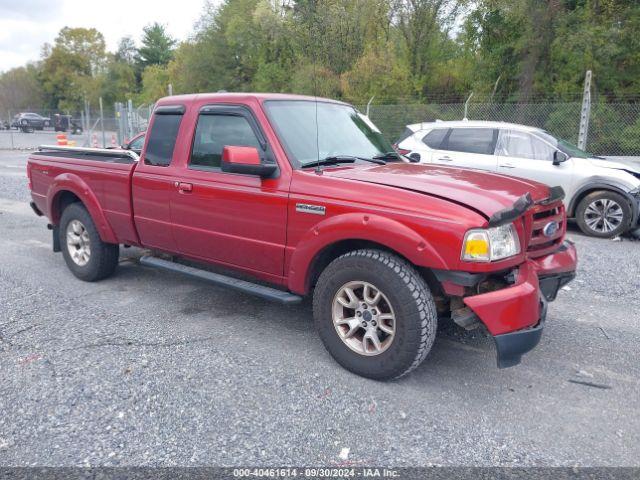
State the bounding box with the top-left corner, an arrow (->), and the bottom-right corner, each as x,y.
59,203 -> 120,282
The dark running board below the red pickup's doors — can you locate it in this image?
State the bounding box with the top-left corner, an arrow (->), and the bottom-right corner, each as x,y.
140,255 -> 302,305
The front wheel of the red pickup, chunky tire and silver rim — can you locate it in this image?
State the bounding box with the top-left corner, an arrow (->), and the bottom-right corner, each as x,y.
313,250 -> 438,380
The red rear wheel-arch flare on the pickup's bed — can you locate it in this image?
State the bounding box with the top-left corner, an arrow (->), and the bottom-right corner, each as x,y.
47,173 -> 118,243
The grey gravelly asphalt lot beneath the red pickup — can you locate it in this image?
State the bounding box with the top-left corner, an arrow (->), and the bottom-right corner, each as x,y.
0,152 -> 640,466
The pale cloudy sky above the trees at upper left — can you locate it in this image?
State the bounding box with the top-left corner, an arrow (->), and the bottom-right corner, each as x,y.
0,0 -> 217,72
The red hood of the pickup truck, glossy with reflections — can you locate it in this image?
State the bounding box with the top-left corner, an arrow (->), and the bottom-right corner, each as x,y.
324,163 -> 549,218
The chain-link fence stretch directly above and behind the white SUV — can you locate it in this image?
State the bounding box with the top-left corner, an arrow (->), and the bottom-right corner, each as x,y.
359,102 -> 640,156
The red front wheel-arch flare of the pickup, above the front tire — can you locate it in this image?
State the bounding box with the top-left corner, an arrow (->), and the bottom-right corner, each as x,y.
287,213 -> 448,294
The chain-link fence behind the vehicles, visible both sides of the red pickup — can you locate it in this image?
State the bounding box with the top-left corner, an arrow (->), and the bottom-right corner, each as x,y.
0,101 -> 640,156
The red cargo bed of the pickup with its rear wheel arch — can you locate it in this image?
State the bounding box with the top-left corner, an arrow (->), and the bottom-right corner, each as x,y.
27,146 -> 138,245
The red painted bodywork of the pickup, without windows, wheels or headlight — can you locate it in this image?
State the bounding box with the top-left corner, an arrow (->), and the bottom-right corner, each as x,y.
28,94 -> 576,335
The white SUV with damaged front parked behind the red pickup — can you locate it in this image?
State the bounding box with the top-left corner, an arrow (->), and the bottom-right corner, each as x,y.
396,120 -> 640,238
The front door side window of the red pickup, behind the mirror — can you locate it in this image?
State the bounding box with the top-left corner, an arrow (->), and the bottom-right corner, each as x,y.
190,115 -> 262,167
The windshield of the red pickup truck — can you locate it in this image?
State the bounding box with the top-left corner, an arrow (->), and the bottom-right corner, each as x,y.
265,100 -> 400,167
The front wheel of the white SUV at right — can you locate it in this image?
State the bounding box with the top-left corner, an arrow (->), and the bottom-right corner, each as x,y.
576,190 -> 632,238
